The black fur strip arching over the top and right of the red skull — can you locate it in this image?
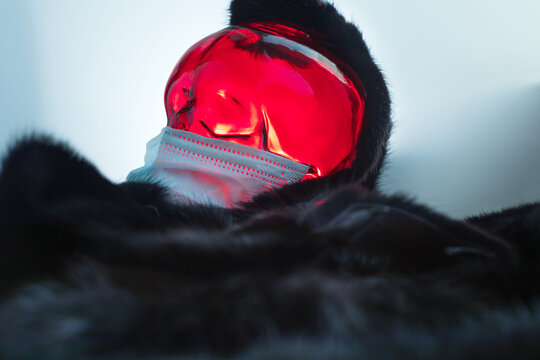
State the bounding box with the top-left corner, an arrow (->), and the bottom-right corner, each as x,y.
230,0 -> 392,189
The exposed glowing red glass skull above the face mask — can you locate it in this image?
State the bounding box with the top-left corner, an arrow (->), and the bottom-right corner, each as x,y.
165,24 -> 364,179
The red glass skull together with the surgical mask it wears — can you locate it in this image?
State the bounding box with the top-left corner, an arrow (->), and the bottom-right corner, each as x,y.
128,24 -> 364,207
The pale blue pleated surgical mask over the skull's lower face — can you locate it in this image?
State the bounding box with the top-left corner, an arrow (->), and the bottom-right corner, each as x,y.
127,127 -> 309,208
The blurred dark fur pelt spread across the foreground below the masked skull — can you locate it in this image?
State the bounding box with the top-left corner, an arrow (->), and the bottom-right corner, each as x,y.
0,138 -> 540,359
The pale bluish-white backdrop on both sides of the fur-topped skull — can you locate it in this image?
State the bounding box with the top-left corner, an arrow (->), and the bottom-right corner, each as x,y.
0,0 -> 540,216
